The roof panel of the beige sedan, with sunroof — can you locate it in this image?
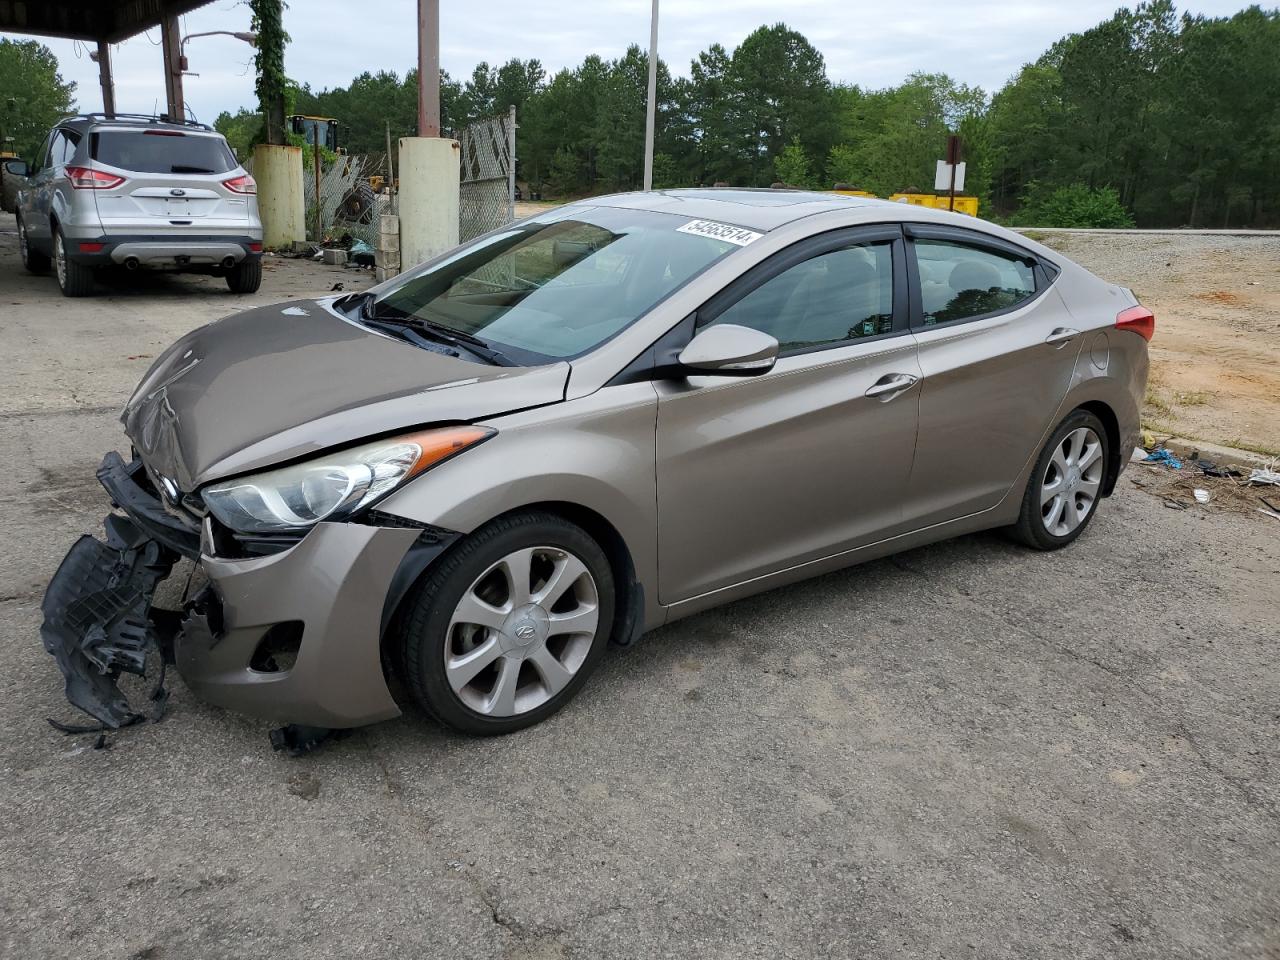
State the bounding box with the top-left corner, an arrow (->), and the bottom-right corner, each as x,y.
582,187 -> 901,232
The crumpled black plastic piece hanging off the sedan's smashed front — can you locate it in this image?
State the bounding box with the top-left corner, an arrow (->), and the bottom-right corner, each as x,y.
40,513 -> 178,728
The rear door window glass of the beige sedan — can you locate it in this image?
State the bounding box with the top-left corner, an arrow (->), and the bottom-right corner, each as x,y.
913,239 -> 1036,326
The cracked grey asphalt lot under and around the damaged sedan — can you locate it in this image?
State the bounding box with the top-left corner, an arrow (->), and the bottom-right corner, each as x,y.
0,218 -> 1280,960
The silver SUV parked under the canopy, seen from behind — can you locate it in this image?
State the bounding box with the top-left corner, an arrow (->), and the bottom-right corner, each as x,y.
10,114 -> 262,297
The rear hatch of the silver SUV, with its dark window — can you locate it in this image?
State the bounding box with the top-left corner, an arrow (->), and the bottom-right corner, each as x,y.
90,128 -> 251,237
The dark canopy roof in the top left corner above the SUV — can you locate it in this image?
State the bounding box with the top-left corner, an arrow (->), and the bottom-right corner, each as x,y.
0,0 -> 210,44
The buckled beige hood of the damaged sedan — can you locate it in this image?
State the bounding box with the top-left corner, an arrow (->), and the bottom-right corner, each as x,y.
120,298 -> 570,492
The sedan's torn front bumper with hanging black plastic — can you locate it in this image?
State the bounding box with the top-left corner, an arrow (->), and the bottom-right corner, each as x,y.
41,453 -> 458,746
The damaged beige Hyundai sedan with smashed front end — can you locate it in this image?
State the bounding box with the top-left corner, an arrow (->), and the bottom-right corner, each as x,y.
42,189 -> 1155,749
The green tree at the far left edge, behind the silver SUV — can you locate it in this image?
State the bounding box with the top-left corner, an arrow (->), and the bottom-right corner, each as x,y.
0,37 -> 76,160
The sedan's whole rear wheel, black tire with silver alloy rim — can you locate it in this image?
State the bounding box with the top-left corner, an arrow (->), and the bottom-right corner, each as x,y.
1010,410 -> 1111,550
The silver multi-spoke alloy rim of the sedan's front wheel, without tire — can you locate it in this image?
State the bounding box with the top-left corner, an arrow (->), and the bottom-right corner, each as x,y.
444,547 -> 599,717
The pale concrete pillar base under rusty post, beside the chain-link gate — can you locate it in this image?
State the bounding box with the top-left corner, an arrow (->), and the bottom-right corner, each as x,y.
399,137 -> 461,270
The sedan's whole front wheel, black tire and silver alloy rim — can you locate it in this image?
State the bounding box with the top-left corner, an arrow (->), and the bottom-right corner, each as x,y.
401,512 -> 614,736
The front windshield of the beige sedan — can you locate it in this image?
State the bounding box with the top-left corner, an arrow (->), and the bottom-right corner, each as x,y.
375,206 -> 742,361
